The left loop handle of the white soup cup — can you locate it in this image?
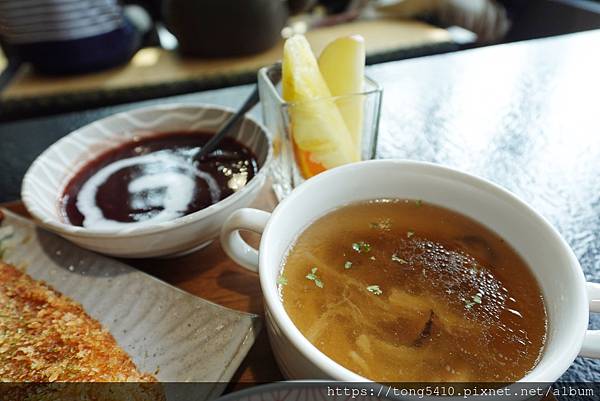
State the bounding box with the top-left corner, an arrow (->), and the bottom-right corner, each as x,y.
221,208 -> 271,272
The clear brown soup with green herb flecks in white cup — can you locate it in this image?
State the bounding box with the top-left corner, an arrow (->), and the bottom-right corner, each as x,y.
281,199 -> 547,382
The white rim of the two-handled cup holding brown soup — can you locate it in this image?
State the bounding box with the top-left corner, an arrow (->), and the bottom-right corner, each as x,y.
258,159 -> 589,384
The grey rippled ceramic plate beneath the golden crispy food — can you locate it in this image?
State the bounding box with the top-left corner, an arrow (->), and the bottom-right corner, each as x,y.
0,210 -> 260,400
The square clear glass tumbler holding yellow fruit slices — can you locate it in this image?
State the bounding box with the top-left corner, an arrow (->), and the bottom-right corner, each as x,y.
258,63 -> 382,200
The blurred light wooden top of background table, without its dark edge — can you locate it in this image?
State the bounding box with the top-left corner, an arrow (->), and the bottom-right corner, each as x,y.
0,19 -> 451,100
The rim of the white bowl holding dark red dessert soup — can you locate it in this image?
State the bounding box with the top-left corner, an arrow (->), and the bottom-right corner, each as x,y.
21,102 -> 273,238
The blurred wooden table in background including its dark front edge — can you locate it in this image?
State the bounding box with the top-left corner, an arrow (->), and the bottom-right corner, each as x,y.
0,19 -> 457,119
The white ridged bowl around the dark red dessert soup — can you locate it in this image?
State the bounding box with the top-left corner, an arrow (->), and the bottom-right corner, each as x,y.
21,104 -> 271,258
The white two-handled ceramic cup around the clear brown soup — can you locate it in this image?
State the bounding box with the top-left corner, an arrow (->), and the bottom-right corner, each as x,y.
221,160 -> 600,390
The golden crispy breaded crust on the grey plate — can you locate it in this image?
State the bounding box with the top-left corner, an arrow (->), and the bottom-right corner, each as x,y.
0,262 -> 156,382
